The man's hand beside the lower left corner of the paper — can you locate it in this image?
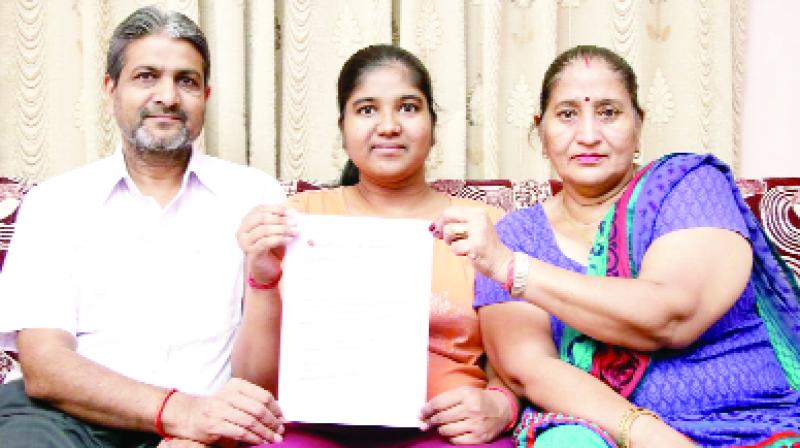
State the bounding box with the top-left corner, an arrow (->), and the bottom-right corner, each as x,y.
164,378 -> 284,444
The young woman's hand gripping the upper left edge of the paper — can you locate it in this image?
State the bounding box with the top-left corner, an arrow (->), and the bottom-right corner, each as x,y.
236,205 -> 297,284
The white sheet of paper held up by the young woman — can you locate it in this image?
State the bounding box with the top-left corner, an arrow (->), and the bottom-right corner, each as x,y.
278,215 -> 433,427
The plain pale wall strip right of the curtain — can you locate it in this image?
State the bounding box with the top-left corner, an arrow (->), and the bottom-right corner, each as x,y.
741,0 -> 800,177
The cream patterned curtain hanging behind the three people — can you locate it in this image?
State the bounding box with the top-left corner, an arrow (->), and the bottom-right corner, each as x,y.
0,0 -> 747,181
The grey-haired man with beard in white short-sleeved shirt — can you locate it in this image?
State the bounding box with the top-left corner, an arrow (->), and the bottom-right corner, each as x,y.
0,7 -> 283,447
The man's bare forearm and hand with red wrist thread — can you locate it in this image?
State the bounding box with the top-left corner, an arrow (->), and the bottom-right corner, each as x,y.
17,329 -> 283,443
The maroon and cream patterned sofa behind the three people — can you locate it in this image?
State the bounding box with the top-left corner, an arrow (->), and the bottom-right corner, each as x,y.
0,177 -> 800,384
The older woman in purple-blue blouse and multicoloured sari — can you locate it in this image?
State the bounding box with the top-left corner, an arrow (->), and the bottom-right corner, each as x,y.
436,46 -> 800,447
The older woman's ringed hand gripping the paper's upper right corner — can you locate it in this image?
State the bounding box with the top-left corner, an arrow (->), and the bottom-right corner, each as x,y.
431,207 -> 513,283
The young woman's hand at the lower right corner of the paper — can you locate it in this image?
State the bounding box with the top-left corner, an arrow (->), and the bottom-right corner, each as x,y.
422,387 -> 514,445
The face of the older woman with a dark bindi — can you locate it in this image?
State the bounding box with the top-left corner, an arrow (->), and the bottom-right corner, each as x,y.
539,59 -> 640,193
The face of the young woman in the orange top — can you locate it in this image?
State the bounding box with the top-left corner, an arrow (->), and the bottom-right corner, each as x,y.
342,63 -> 433,184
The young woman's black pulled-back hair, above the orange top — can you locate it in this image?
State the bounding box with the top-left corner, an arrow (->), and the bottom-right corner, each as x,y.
336,44 -> 436,186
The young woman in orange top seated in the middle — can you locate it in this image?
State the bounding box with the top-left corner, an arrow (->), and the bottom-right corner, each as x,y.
233,45 -> 517,448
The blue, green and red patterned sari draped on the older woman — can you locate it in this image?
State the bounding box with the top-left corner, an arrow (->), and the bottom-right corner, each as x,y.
515,154 -> 800,447
